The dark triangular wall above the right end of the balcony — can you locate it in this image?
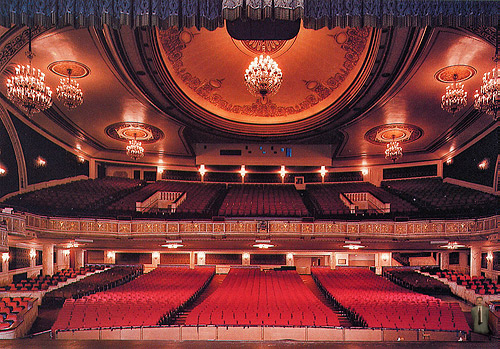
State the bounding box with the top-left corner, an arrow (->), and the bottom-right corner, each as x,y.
443,128 -> 500,187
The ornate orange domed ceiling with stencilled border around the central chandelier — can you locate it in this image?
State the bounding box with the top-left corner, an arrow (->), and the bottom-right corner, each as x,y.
157,27 -> 375,125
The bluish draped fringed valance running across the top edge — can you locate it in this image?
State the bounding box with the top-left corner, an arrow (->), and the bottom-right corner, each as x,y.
0,0 -> 500,30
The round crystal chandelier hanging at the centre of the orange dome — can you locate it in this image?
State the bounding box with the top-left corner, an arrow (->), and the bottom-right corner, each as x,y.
245,55 -> 283,100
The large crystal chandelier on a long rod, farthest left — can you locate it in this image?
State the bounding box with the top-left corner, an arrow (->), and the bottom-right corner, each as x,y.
7,28 -> 52,116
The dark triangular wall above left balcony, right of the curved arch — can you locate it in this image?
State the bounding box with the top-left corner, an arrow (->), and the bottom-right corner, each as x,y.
11,114 -> 89,184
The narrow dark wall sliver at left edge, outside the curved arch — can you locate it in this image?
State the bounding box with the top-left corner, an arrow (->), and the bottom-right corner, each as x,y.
0,117 -> 19,197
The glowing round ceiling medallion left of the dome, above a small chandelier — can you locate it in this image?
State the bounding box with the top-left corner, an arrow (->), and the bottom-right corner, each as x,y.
105,122 -> 165,144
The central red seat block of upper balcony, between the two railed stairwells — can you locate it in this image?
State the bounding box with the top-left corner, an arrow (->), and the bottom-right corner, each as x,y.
219,184 -> 309,217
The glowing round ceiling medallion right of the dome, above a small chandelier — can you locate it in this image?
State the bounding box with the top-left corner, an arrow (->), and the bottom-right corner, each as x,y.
365,124 -> 424,145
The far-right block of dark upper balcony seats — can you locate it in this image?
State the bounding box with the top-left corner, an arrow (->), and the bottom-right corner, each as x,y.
382,178 -> 500,215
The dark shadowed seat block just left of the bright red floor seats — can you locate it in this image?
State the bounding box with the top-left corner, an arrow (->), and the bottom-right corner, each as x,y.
43,266 -> 142,306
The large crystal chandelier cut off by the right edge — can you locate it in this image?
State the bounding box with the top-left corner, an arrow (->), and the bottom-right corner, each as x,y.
474,28 -> 500,121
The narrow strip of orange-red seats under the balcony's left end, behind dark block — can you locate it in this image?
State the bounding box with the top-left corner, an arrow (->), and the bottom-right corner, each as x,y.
0,266 -> 104,292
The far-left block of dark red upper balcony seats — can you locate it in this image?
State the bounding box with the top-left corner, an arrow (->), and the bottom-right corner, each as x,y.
5,177 -> 142,215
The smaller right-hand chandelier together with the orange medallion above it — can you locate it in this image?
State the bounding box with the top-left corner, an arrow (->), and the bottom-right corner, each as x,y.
434,65 -> 476,115
